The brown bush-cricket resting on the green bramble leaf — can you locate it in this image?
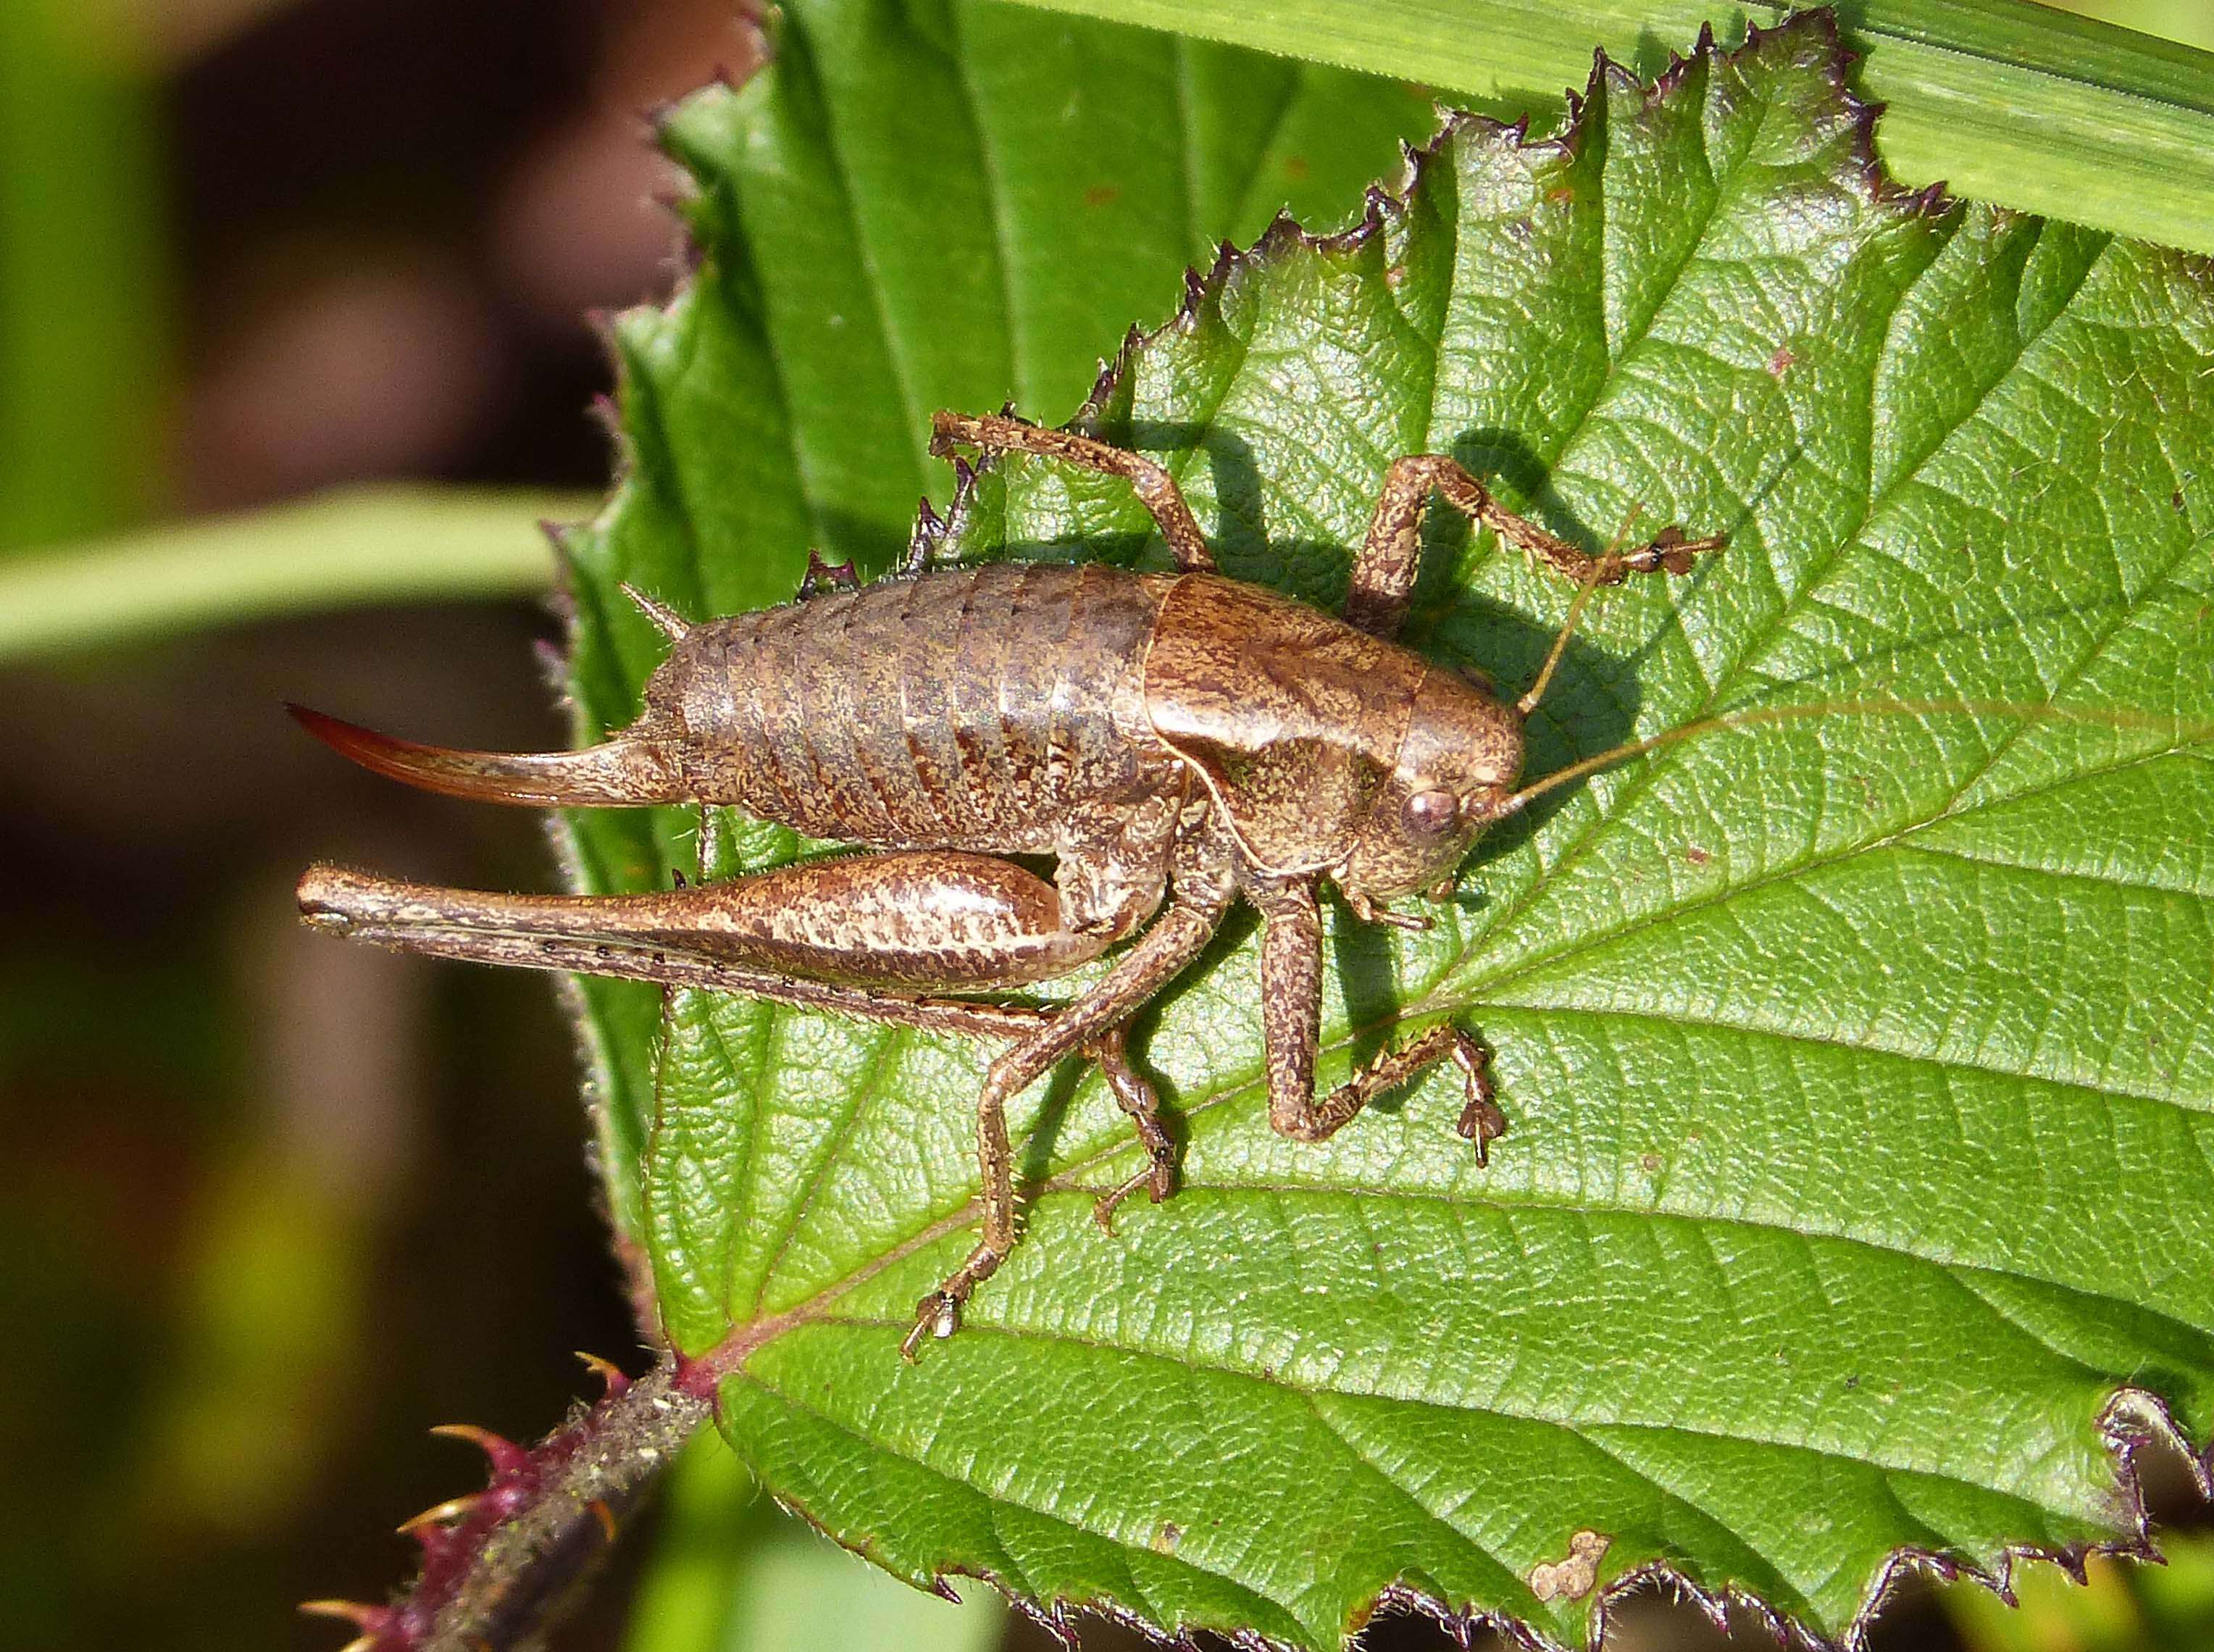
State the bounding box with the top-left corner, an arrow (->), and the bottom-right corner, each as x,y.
297,414 -> 1723,1358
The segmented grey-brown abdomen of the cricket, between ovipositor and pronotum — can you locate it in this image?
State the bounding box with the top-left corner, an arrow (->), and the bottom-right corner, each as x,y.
680,562 -> 1176,853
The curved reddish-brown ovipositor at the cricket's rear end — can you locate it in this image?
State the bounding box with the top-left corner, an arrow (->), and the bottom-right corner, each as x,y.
285,704 -> 690,809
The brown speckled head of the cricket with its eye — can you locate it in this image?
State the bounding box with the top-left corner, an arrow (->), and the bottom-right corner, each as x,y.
1333,667 -> 1524,906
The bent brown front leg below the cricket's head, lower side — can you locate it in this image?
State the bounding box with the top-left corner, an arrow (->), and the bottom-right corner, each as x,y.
1247,879 -> 1508,1165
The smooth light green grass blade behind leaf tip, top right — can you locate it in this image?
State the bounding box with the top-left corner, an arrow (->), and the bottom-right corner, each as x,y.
996,0 -> 2214,252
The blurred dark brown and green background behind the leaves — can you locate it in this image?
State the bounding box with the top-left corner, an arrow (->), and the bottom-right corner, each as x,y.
0,0 -> 2214,1652
